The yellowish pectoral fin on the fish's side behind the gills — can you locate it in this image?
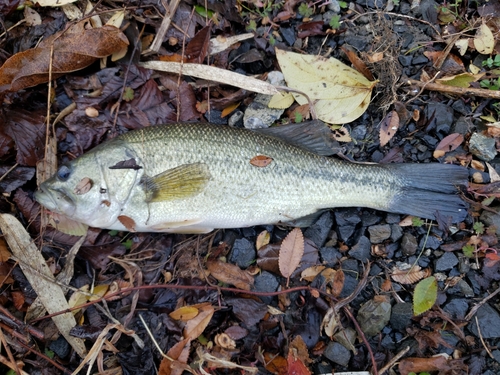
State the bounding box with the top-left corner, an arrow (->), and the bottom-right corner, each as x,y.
141,163 -> 210,203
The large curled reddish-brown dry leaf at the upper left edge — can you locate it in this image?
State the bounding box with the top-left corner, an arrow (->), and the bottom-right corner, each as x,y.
0,22 -> 128,92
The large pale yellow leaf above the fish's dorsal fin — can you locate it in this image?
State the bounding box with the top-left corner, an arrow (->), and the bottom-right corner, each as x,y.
276,49 -> 377,124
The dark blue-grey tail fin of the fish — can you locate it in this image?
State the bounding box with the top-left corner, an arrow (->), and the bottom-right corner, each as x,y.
386,163 -> 469,223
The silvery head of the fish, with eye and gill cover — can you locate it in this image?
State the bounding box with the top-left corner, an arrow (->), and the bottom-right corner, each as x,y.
35,144 -> 142,228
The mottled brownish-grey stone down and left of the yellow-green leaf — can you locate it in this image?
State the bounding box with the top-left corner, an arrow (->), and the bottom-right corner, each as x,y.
357,298 -> 391,336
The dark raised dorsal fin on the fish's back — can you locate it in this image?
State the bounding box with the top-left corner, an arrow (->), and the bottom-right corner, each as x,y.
256,120 -> 340,156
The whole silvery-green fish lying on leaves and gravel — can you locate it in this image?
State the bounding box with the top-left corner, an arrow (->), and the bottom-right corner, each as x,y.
34,122 -> 468,233
